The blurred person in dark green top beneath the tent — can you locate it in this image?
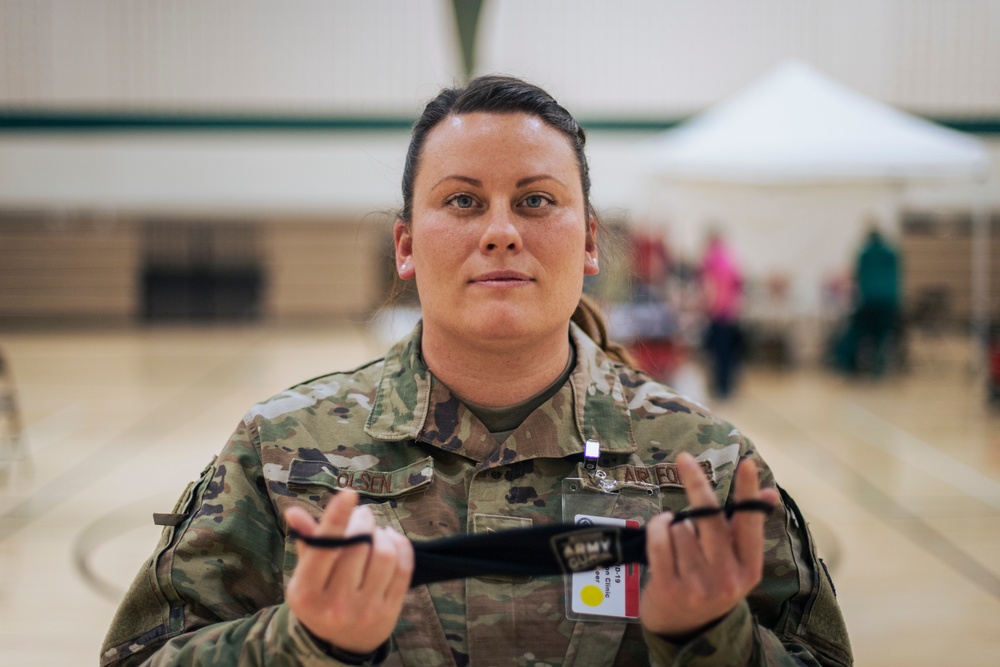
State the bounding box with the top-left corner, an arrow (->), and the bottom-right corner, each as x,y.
837,226 -> 901,377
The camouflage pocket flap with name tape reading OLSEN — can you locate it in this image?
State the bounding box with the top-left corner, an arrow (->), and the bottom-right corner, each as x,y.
288,456 -> 434,502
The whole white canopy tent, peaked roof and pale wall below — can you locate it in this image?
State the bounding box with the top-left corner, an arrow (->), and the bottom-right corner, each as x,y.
639,61 -> 989,354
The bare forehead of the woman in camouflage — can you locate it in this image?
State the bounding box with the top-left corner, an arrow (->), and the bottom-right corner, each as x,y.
417,112 -> 579,179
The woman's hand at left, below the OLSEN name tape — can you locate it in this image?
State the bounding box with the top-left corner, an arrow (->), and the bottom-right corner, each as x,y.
285,489 -> 413,654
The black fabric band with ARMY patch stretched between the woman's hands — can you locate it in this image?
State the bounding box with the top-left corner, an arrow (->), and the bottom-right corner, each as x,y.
289,500 -> 774,588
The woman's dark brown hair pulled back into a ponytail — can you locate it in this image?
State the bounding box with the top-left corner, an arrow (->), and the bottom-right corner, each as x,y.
397,74 -> 635,366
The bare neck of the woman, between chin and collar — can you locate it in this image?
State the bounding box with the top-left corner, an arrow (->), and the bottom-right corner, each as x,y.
421,322 -> 570,408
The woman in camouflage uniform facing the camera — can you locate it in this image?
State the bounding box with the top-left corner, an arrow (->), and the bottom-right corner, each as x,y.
101,77 -> 851,666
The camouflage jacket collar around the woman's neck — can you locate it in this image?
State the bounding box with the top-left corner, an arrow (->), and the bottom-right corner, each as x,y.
365,323 -> 636,463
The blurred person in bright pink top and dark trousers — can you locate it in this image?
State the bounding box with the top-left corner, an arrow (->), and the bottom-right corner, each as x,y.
699,231 -> 743,399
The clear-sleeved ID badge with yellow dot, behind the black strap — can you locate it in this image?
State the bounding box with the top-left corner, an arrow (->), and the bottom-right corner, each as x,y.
562,473 -> 660,622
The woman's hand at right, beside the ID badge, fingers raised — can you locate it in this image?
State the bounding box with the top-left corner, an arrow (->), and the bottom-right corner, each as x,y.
639,452 -> 778,637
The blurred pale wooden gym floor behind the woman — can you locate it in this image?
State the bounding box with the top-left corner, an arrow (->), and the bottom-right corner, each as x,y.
0,324 -> 1000,667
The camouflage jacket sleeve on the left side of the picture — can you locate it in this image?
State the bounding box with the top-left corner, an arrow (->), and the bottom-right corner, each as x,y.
101,421 -> 337,667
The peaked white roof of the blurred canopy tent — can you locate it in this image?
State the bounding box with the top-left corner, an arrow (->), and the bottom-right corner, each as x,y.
648,61 -> 988,186
